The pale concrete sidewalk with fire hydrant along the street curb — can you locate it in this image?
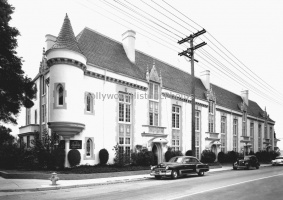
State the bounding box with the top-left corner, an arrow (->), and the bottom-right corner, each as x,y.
0,164 -> 271,192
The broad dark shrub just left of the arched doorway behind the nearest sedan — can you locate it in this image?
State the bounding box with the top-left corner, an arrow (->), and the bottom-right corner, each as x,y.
131,149 -> 154,166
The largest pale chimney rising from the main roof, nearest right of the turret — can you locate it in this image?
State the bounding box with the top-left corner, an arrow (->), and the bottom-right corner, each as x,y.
122,30 -> 136,63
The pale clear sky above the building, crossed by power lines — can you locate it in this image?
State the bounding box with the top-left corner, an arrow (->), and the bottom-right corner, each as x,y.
4,0 -> 283,149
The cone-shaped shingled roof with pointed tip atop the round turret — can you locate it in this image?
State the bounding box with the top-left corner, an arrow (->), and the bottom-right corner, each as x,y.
51,14 -> 83,54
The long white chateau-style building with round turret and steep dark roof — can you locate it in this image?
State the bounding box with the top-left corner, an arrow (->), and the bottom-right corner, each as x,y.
19,15 -> 277,166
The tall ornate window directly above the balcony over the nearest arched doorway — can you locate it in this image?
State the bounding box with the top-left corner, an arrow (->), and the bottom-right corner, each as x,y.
149,82 -> 159,126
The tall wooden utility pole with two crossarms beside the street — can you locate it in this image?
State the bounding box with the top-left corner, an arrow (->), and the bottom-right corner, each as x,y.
178,29 -> 206,156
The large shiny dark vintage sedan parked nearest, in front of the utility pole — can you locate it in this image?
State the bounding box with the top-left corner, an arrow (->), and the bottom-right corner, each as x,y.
150,156 -> 209,179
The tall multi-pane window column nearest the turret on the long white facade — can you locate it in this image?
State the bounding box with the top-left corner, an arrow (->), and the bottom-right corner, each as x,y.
118,93 -> 132,156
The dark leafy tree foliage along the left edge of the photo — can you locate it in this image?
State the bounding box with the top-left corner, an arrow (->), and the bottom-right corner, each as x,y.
0,0 -> 36,124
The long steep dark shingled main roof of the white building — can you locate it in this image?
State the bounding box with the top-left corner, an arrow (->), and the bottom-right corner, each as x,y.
77,28 -> 272,118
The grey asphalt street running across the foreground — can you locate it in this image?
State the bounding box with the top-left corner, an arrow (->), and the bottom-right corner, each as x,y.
0,166 -> 283,200
